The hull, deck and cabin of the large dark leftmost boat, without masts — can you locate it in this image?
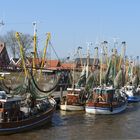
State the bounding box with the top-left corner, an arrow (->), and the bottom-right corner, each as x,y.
0,91 -> 55,135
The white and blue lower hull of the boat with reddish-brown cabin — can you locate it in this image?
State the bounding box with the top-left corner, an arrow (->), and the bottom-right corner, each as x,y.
85,103 -> 127,114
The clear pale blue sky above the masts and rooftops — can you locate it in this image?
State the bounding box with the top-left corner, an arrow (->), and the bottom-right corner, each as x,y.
0,0 -> 140,58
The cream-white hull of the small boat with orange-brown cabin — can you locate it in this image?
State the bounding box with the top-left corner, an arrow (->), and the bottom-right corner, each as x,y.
60,104 -> 84,111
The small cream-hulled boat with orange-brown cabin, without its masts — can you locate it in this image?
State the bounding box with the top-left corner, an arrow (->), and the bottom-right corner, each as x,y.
60,88 -> 86,111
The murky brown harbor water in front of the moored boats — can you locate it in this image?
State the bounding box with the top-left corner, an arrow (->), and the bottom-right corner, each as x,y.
0,103 -> 140,140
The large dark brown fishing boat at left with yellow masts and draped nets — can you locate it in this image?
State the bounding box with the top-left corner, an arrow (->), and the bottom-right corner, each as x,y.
0,30 -> 57,135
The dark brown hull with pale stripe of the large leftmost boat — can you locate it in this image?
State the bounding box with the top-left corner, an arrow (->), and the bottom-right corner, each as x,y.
0,107 -> 55,135
